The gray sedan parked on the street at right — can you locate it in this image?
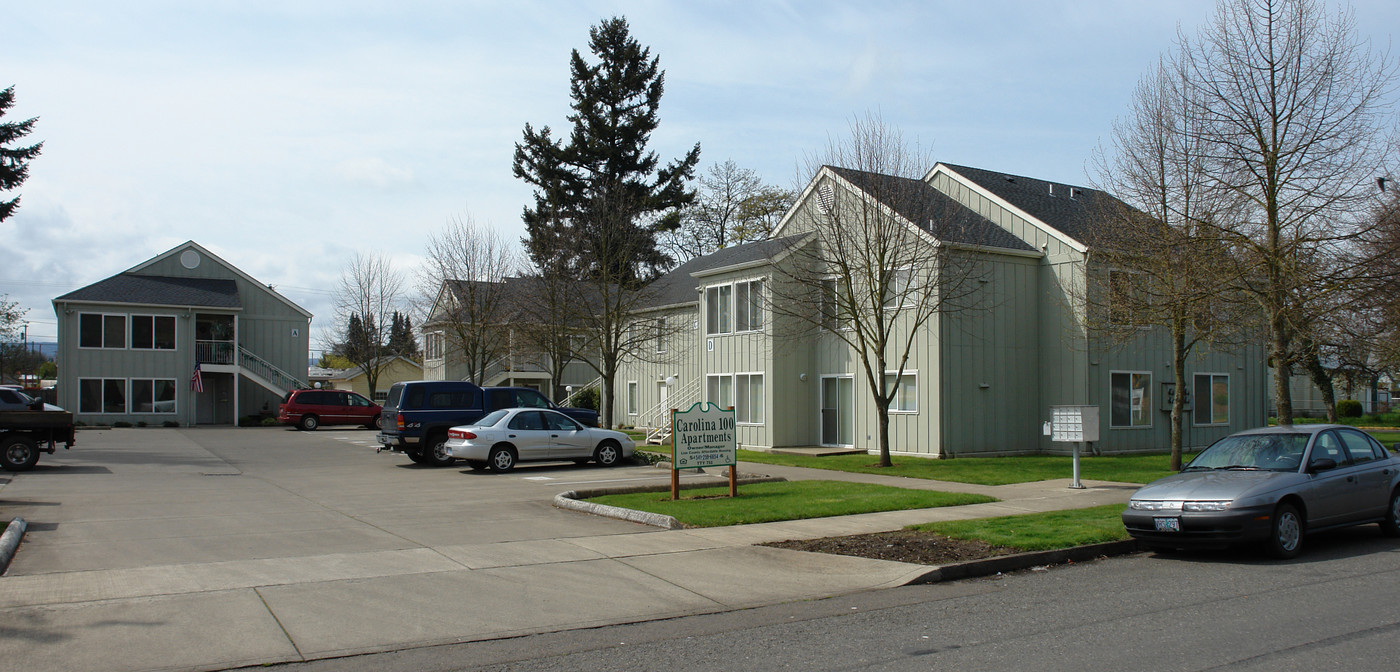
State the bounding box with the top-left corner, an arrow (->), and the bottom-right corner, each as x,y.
1123,424 -> 1400,557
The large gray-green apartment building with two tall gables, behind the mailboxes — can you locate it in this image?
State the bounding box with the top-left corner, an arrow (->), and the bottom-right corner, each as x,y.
612,164 -> 1267,458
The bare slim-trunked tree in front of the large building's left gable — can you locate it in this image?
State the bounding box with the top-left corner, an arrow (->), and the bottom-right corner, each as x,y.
770,115 -> 986,466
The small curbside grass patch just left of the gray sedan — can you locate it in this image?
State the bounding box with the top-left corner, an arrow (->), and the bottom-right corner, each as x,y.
909,504 -> 1128,550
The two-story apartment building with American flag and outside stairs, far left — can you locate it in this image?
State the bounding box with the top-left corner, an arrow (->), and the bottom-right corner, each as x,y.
53,241 -> 311,426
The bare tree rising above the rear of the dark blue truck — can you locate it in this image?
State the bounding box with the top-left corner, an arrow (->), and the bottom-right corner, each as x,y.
419,217 -> 521,385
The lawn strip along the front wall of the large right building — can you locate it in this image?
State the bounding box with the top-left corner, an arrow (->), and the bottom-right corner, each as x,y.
739,451 -> 1189,486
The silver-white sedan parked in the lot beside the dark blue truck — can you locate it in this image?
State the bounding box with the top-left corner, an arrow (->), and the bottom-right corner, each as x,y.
447,409 -> 636,472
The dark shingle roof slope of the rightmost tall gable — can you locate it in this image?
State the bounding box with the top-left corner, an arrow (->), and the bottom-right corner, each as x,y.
944,164 -> 1124,244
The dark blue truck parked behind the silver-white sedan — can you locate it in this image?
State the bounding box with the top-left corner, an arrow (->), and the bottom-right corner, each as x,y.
378,381 -> 598,466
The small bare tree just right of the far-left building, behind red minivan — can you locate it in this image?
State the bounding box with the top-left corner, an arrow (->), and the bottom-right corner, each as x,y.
333,253 -> 403,396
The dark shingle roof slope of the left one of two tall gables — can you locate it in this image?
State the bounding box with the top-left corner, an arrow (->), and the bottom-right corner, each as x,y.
830,165 -> 1035,251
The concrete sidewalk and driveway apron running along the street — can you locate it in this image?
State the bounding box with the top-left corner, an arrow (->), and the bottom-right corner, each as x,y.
0,434 -> 1135,671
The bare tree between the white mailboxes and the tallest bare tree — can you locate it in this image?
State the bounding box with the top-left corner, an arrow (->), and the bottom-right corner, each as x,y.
1085,53 -> 1254,469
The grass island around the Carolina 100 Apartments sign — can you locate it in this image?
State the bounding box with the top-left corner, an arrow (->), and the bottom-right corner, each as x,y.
588,480 -> 997,528
